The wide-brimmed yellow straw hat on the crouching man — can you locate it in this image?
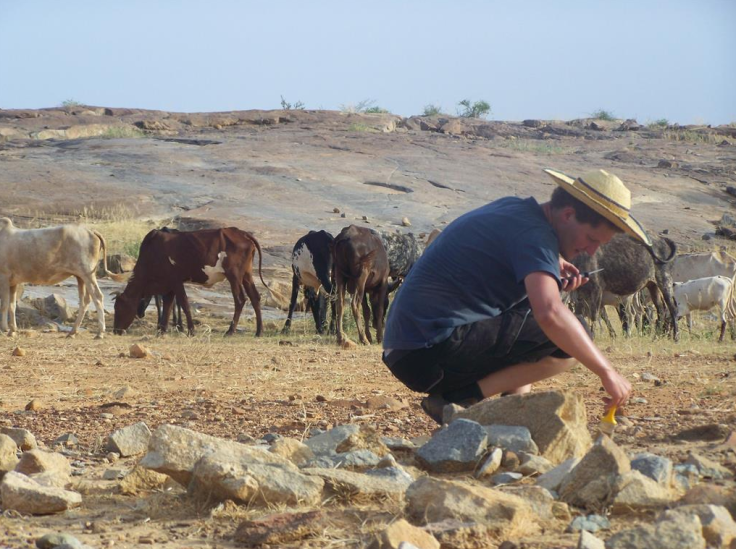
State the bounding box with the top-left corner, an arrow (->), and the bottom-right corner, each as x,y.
544,168 -> 652,247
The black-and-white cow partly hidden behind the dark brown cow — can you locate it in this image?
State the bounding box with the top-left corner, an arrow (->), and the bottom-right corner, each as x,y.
282,231 -> 335,334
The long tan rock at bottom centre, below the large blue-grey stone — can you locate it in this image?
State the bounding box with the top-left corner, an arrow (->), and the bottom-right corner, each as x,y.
406,477 -> 536,536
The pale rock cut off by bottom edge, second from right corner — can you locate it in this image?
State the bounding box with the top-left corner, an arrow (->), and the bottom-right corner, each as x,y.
606,515 -> 705,549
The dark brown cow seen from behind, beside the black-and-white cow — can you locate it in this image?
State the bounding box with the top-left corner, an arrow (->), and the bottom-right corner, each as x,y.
333,225 -> 389,345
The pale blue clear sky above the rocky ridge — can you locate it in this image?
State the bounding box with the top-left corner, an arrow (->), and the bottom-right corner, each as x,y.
0,0 -> 736,125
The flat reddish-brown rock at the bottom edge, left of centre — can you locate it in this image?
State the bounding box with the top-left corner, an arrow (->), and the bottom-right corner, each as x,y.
234,510 -> 324,547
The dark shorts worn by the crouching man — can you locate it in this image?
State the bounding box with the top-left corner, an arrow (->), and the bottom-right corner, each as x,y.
383,308 -> 590,394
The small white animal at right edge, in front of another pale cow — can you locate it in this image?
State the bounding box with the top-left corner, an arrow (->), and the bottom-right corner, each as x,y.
675,276 -> 736,341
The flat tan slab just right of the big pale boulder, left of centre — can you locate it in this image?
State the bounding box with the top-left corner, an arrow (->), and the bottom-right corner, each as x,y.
302,468 -> 406,503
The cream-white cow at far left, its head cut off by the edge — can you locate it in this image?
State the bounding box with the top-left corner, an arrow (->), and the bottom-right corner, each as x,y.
0,217 -> 109,338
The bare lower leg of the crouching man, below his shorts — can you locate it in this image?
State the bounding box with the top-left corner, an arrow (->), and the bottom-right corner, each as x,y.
478,356 -> 577,398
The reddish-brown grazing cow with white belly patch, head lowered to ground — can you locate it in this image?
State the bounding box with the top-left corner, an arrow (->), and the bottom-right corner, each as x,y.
114,227 -> 268,336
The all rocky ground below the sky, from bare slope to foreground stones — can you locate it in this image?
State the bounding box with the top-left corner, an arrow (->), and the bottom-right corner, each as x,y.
0,107 -> 736,549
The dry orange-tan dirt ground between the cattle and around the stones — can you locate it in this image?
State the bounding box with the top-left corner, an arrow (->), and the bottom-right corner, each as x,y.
0,310 -> 736,548
